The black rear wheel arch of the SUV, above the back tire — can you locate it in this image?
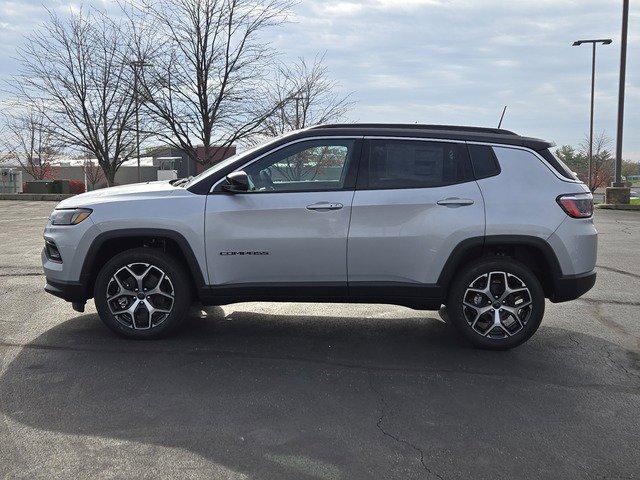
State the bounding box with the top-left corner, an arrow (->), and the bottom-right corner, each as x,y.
438,235 -> 562,298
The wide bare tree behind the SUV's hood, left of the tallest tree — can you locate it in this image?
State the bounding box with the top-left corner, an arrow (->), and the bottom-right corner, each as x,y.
10,11 -> 134,185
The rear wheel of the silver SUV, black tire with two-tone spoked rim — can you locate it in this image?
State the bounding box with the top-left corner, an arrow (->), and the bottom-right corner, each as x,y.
446,257 -> 545,350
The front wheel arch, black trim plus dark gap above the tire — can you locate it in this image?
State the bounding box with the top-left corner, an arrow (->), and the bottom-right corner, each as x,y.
80,228 -> 205,298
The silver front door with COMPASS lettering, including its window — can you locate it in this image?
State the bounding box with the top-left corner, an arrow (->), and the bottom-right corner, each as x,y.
205,138 -> 361,295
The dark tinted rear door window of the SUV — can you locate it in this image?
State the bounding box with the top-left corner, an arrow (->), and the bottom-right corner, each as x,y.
368,140 -> 473,189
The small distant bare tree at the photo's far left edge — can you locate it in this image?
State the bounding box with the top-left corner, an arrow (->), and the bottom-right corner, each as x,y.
3,109 -> 58,180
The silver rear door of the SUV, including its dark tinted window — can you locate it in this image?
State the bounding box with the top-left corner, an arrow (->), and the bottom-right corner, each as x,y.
347,138 -> 485,296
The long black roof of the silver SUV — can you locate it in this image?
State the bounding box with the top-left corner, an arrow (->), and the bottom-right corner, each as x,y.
308,123 -> 554,150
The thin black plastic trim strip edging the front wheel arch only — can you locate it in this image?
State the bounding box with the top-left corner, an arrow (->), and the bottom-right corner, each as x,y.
80,228 -> 206,290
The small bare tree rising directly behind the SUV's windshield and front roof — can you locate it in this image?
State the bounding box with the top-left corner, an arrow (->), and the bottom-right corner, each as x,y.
262,55 -> 354,137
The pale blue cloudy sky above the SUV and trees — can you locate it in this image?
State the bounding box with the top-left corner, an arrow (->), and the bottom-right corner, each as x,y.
0,0 -> 640,161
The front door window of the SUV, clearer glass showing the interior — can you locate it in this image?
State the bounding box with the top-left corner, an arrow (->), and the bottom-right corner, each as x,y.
244,139 -> 354,192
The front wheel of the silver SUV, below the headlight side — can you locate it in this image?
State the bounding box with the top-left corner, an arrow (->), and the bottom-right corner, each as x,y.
93,248 -> 192,340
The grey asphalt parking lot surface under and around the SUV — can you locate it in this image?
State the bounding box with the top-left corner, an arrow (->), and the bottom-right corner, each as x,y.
0,201 -> 640,479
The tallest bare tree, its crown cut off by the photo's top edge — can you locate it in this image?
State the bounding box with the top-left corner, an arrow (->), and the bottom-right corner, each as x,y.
129,0 -> 298,165
